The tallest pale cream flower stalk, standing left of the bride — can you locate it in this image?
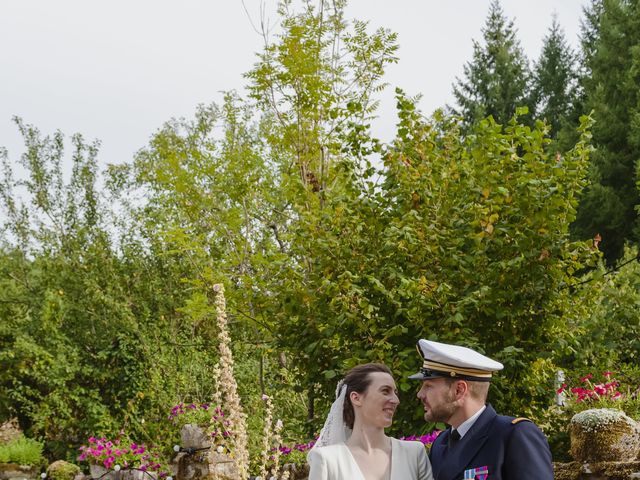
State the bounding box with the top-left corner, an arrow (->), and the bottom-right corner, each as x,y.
209,284 -> 249,479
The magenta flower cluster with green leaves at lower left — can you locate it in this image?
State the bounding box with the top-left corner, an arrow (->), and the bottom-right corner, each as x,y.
78,437 -> 168,478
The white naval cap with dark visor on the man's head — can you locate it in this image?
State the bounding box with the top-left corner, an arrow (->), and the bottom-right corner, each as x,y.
409,339 -> 504,382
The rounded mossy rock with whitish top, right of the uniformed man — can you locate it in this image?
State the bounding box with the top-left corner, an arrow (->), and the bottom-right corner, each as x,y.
569,408 -> 640,463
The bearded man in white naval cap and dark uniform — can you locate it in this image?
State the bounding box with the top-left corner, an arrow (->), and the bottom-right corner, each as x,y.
409,340 -> 553,480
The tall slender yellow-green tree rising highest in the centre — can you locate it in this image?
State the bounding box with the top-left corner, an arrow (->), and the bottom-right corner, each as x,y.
242,1 -> 398,428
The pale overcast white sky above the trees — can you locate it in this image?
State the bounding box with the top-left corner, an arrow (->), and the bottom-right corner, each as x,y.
0,0 -> 586,170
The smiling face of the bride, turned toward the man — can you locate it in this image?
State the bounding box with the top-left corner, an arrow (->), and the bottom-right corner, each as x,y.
351,372 -> 400,428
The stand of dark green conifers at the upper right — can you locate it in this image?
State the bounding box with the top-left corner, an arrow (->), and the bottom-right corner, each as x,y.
453,0 -> 640,266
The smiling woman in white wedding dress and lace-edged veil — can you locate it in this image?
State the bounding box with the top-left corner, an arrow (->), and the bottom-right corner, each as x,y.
307,363 -> 433,480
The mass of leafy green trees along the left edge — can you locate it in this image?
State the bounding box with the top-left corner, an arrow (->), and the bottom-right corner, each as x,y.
0,120 -> 212,459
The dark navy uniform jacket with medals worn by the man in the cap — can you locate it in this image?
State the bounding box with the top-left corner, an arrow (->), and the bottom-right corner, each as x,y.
429,405 -> 553,480
